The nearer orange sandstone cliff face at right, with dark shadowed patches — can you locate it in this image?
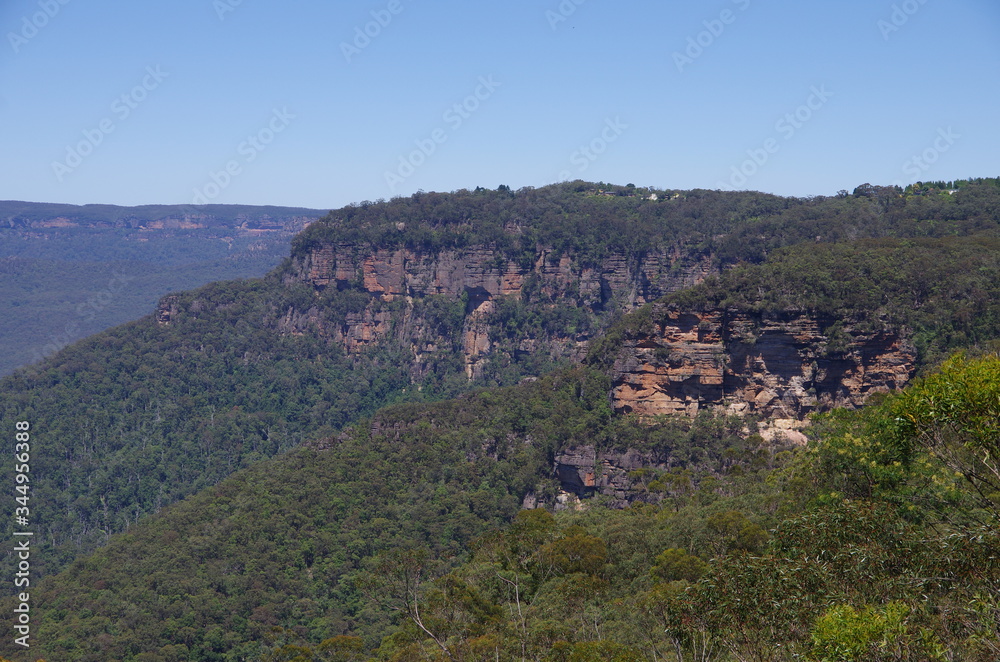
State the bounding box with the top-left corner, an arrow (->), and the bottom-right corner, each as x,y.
611,305 -> 916,420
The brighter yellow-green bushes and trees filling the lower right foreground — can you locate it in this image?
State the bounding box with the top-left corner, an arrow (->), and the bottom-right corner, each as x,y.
263,355 -> 1000,662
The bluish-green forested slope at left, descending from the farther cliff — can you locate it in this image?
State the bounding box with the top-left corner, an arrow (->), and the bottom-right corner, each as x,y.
2,280 -> 456,588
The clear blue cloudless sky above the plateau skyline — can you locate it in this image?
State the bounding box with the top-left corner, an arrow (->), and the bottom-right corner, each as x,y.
0,0 -> 1000,208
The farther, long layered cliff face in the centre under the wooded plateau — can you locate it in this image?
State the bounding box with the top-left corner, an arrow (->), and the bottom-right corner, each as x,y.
280,244 -> 711,378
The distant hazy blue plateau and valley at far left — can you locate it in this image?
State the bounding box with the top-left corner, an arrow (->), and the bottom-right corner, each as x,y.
0,201 -> 325,375
